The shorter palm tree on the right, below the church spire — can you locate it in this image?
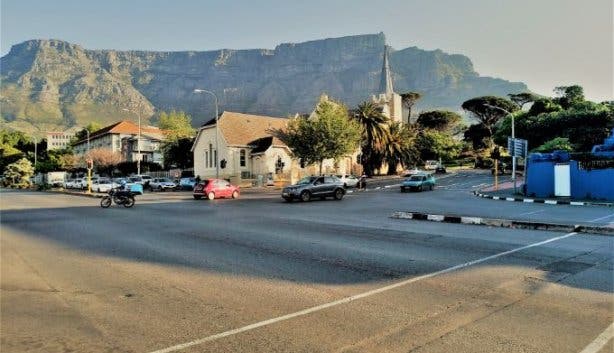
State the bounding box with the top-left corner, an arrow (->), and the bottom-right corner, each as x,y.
384,122 -> 420,175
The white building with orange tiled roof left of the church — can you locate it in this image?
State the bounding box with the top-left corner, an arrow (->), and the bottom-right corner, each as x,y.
73,120 -> 164,164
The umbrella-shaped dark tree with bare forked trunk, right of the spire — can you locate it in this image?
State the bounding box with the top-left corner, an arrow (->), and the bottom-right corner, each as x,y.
462,96 -> 520,148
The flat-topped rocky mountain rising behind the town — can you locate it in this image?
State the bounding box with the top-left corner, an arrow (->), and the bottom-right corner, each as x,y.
0,33 -> 527,132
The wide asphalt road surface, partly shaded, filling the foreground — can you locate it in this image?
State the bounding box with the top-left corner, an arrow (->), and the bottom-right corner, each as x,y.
0,175 -> 614,353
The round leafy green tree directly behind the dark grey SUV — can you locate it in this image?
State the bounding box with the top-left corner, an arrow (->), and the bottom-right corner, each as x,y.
272,97 -> 361,174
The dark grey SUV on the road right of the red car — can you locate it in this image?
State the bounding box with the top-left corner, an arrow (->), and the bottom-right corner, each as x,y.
281,176 -> 345,202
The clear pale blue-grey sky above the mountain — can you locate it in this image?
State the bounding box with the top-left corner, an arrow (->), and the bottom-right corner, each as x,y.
0,0 -> 614,101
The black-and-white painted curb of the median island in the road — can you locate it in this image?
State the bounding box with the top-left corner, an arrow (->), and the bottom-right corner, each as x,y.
390,211 -> 614,236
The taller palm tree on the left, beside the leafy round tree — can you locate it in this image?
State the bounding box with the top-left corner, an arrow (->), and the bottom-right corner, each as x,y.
352,101 -> 390,175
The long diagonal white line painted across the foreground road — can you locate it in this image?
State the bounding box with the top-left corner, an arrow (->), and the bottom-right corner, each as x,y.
150,232 -> 584,353
